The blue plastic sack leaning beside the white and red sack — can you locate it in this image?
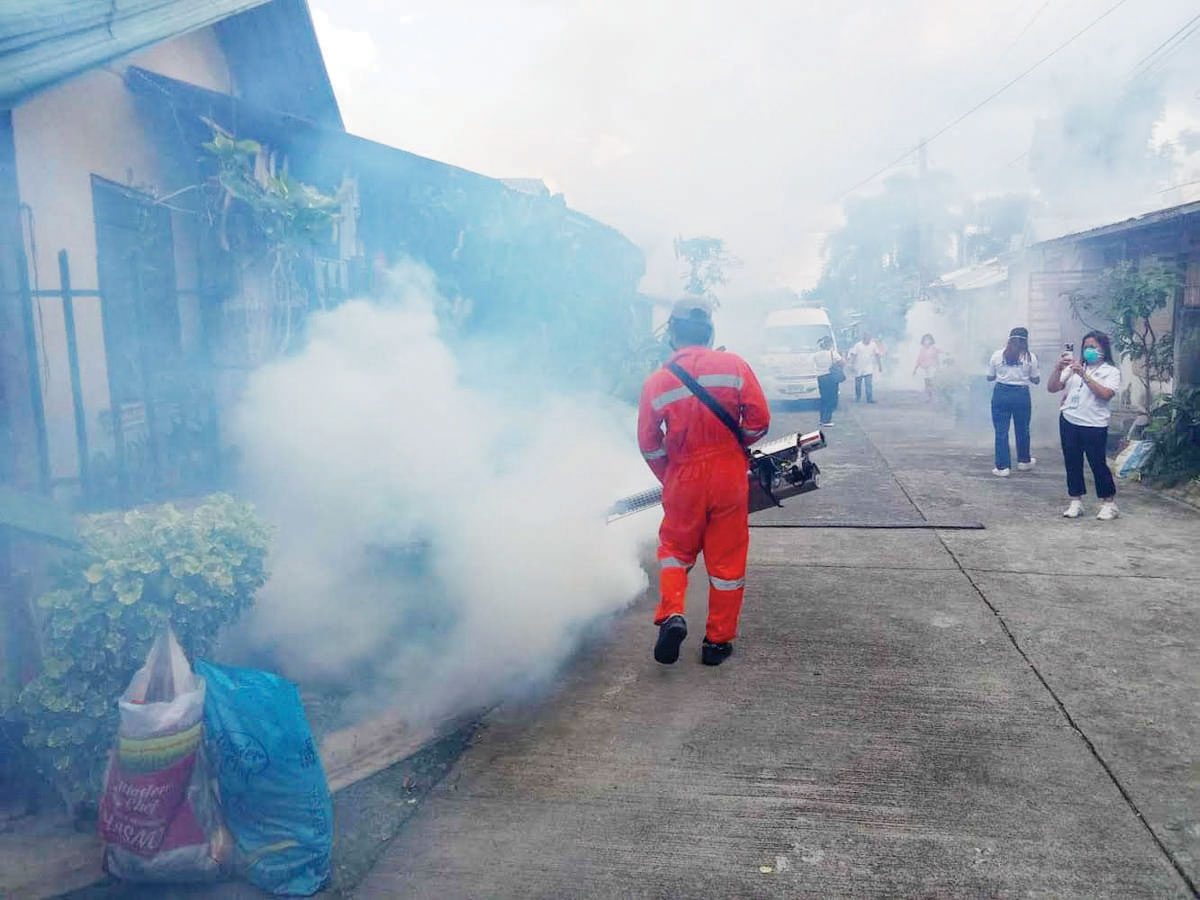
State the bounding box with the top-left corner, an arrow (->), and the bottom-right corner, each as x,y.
196,660 -> 334,896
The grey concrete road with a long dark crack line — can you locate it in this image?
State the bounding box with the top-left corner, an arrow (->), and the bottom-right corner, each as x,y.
360,390 -> 1200,900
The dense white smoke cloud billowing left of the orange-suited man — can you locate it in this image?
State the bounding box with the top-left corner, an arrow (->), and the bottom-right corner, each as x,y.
225,266 -> 656,716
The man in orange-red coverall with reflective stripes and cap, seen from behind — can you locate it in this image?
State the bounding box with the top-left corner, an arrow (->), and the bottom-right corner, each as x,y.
637,298 -> 770,666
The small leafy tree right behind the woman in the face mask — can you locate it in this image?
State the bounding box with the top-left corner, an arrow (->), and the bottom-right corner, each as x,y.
1068,259 -> 1180,412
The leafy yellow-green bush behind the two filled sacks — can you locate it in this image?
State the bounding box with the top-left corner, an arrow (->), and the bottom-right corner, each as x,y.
11,494 -> 270,804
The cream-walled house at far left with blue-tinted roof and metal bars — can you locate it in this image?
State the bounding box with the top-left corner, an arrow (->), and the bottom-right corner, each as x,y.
0,0 -> 342,511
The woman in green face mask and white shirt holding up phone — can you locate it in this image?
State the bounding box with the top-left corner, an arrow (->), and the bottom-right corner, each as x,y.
1046,331 -> 1121,518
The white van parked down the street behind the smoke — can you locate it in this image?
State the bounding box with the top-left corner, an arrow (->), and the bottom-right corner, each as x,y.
758,306 -> 838,400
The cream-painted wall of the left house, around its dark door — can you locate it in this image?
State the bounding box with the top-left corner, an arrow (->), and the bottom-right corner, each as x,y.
13,29 -> 233,494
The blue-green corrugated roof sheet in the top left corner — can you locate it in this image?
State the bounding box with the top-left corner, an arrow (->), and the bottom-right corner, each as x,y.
0,0 -> 266,108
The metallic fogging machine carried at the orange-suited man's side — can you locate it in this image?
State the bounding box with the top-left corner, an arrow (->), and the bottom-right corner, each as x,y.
608,431 -> 826,522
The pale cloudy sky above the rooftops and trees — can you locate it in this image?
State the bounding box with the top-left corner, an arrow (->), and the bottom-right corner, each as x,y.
310,0 -> 1200,294
